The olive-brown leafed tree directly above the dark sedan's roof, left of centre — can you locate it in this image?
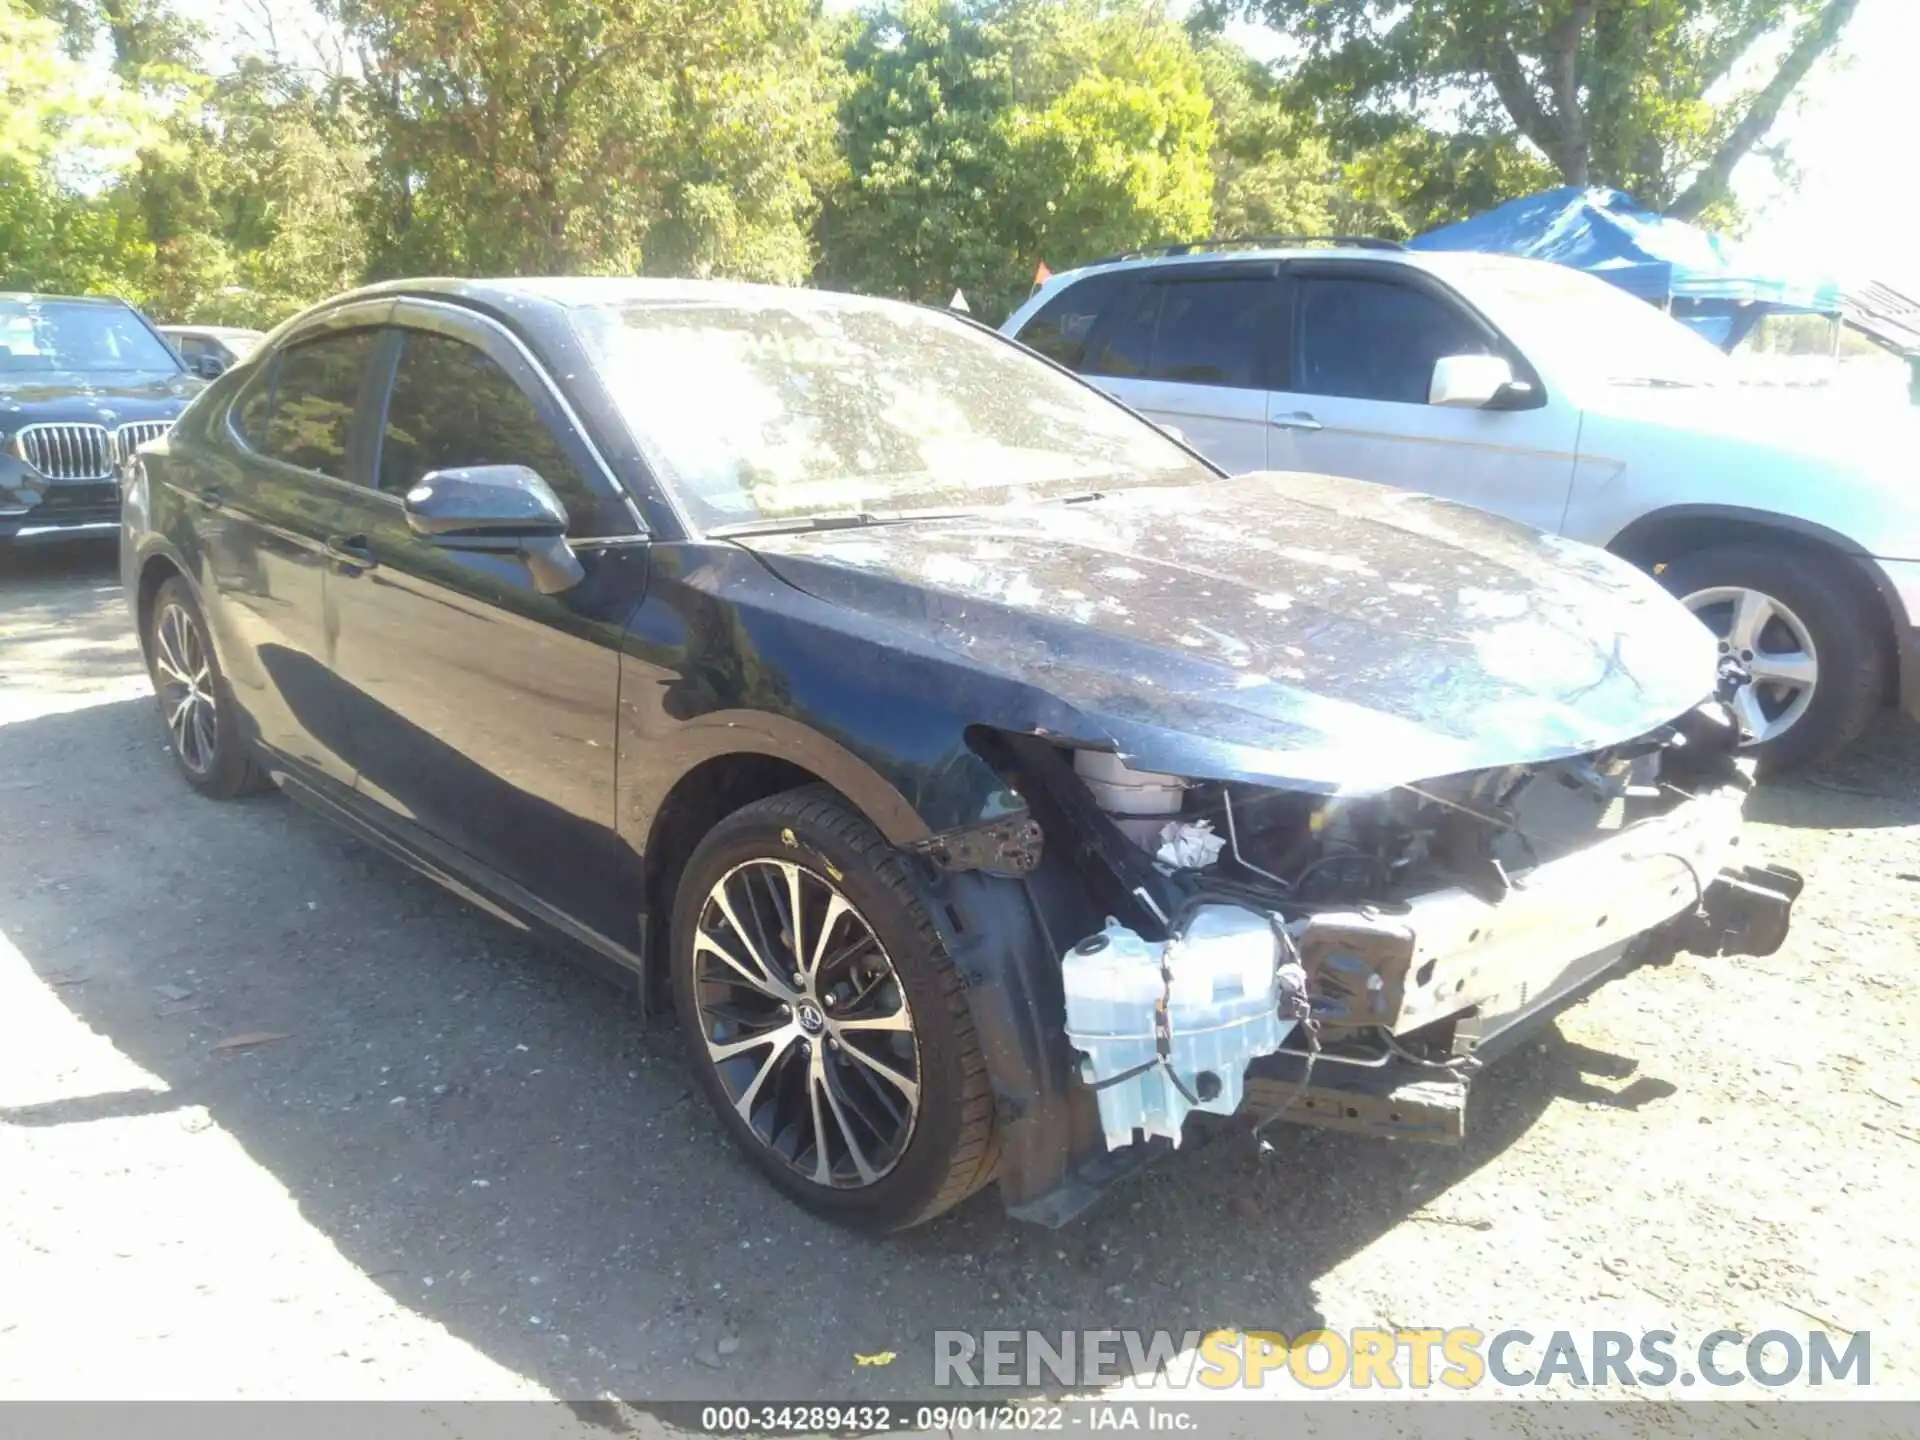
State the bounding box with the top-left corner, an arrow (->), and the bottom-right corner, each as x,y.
330,0 -> 833,280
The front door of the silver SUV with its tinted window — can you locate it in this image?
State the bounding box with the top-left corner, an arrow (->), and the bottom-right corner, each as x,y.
1269,261 -> 1580,530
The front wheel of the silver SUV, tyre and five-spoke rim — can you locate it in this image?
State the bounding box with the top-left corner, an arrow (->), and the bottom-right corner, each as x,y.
1659,543 -> 1887,774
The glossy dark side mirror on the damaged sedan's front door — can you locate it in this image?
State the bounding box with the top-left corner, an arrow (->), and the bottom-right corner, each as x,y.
403,465 -> 586,595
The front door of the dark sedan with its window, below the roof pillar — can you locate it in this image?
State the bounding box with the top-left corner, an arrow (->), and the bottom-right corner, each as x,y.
316,311 -> 647,939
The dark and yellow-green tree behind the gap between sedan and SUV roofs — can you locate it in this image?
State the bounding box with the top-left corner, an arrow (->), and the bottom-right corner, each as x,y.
820,0 -> 1213,317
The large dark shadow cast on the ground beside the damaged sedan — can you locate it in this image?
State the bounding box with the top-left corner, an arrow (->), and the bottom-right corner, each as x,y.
0,701 -> 1670,1398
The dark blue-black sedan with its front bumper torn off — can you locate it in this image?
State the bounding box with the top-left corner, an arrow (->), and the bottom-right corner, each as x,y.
123,280 -> 1799,1229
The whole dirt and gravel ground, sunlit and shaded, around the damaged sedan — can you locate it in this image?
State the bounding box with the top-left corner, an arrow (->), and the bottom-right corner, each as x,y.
0,551 -> 1920,1420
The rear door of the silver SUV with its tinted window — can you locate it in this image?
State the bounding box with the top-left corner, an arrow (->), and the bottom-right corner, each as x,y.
1020,261 -> 1284,474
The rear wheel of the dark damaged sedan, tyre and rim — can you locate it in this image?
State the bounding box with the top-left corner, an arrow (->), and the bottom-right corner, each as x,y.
142,576 -> 273,801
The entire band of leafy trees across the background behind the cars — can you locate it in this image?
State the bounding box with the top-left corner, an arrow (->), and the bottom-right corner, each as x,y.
0,0 -> 1857,323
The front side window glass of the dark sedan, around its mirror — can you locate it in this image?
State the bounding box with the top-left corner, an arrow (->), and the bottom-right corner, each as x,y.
380,330 -> 618,540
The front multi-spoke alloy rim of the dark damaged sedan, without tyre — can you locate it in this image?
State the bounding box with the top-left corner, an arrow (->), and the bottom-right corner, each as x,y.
693,860 -> 920,1190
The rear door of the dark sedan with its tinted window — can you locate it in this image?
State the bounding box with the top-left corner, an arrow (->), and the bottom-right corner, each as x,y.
194,301 -> 390,787
